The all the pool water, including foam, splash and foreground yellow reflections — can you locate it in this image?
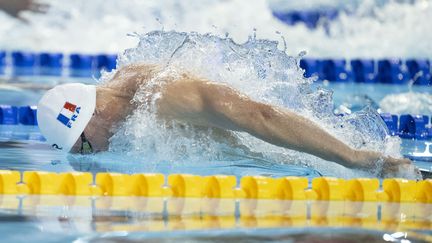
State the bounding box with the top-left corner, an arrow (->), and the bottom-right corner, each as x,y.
0,0 -> 432,242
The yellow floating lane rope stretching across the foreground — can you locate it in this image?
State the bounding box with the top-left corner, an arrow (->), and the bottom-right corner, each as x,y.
0,170 -> 432,203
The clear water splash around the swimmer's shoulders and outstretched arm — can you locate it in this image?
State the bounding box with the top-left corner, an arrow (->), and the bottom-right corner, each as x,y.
95,31 -> 414,177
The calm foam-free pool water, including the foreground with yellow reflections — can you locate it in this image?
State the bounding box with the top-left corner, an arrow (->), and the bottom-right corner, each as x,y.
0,70 -> 432,242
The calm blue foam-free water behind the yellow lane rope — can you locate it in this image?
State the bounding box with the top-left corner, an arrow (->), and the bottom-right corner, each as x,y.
0,77 -> 432,178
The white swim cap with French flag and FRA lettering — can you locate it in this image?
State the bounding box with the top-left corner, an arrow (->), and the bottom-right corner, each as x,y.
37,83 -> 96,152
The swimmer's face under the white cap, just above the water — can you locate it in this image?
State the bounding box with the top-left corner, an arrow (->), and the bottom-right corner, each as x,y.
70,110 -> 111,153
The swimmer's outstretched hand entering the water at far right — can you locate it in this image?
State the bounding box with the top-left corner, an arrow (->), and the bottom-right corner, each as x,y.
351,150 -> 422,179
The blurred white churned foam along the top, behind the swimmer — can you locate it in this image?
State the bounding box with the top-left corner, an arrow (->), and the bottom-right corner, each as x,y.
0,0 -> 432,58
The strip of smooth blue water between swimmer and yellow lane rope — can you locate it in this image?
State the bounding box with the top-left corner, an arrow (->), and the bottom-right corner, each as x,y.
0,141 -> 320,177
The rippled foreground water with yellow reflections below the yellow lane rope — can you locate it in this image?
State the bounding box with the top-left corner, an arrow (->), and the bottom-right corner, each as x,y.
0,195 -> 432,242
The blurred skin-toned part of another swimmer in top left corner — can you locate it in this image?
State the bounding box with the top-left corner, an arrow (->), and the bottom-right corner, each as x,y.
0,0 -> 48,18
